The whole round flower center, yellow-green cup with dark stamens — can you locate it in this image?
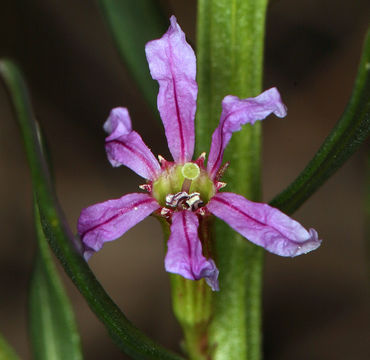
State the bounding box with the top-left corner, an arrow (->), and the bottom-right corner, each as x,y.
152,162 -> 216,210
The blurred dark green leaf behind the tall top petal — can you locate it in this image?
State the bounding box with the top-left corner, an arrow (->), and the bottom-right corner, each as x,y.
98,0 -> 168,113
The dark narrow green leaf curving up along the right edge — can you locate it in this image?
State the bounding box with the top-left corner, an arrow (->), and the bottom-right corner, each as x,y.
270,31 -> 370,214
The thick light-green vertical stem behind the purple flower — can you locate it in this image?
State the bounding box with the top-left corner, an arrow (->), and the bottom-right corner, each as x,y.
196,0 -> 267,360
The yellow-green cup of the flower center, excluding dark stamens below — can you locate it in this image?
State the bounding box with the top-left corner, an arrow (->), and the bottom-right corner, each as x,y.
152,162 -> 215,206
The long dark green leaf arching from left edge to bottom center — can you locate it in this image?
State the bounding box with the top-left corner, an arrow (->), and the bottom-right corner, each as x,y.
0,60 -> 181,360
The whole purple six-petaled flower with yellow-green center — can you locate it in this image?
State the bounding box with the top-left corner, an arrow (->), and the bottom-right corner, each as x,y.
78,16 -> 321,290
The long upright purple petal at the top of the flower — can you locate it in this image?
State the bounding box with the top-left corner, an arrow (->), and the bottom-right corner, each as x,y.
145,16 -> 198,162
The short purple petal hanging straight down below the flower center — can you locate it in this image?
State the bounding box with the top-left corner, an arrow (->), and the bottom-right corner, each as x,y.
164,210 -> 219,291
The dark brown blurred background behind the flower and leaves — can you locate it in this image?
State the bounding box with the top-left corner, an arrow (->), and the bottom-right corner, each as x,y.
0,0 -> 370,360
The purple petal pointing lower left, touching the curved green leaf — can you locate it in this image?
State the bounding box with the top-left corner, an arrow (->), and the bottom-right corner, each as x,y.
77,193 -> 160,257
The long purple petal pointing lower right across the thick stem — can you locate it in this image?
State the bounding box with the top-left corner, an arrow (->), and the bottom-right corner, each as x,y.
207,193 -> 321,257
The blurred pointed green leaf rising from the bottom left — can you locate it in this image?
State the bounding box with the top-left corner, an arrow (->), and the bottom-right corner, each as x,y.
29,204 -> 82,360
